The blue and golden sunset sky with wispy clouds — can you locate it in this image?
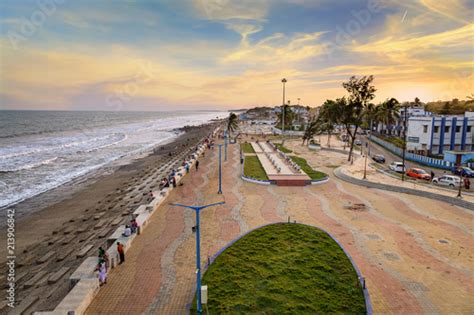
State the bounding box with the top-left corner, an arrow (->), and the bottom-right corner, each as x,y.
0,0 -> 474,111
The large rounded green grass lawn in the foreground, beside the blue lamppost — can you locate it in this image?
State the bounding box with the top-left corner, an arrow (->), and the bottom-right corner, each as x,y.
191,223 -> 366,314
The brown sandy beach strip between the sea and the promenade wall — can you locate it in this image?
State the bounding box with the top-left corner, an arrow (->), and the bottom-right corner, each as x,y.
0,123 -> 216,311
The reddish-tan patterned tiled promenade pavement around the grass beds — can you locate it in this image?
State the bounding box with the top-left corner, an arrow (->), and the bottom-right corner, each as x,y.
87,144 -> 474,314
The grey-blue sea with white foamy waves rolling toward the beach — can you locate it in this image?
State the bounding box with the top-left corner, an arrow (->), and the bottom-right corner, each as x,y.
0,110 -> 228,208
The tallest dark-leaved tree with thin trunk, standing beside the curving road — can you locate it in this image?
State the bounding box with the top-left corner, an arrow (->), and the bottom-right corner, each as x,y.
336,75 -> 377,161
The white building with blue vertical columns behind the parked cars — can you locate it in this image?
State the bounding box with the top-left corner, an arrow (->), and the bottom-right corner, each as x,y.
407,112 -> 474,155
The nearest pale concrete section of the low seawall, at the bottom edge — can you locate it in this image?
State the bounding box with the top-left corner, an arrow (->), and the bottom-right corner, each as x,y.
34,278 -> 100,315
